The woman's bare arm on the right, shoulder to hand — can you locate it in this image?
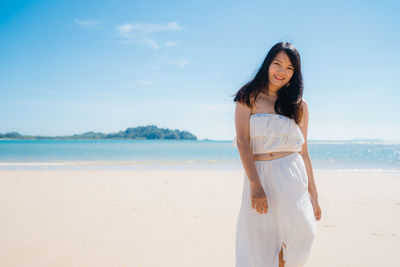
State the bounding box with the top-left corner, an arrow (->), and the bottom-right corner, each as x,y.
299,99 -> 321,220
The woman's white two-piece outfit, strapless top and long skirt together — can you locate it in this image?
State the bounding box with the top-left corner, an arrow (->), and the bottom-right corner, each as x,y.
233,113 -> 317,267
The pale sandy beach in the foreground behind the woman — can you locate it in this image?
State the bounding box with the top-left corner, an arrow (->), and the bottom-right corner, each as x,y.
0,170 -> 400,267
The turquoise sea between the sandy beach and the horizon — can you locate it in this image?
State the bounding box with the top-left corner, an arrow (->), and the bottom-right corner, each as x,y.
0,140 -> 400,172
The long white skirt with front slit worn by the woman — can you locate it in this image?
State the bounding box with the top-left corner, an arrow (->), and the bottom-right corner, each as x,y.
236,152 -> 317,267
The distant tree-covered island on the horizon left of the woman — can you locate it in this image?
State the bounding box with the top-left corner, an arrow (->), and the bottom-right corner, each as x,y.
0,125 -> 197,140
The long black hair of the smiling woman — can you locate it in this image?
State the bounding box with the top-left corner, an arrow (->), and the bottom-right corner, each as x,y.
233,42 -> 303,123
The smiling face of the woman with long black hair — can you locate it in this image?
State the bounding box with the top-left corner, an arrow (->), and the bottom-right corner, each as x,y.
268,51 -> 294,89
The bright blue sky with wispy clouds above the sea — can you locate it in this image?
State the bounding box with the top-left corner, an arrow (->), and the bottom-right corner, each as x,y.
0,0 -> 400,140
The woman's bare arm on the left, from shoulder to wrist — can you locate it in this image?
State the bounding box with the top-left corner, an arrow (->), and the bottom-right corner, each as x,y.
235,102 -> 260,187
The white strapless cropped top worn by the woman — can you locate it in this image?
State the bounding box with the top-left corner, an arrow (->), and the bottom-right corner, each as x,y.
232,113 -> 304,154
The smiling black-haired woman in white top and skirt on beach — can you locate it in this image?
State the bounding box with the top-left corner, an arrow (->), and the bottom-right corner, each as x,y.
234,42 -> 321,267
